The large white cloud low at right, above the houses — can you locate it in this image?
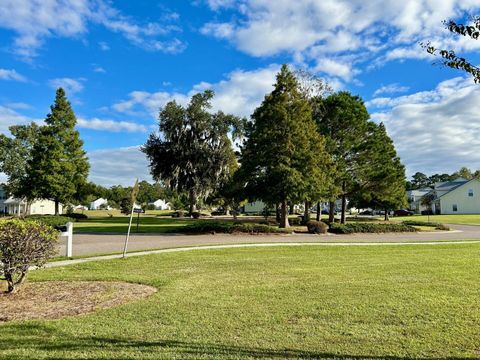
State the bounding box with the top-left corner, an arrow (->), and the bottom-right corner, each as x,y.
372,78 -> 480,174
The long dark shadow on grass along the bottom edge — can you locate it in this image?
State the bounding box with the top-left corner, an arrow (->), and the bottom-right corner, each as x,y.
0,323 -> 477,360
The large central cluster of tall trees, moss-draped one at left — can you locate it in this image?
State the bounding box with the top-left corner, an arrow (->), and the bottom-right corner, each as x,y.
143,65 -> 405,227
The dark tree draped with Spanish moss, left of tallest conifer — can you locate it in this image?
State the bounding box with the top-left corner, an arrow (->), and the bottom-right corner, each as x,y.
142,90 -> 242,215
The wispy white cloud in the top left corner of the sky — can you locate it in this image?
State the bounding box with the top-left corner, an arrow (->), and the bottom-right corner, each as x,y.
0,0 -> 185,59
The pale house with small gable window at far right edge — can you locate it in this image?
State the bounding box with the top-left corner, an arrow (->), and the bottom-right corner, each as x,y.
406,178 -> 480,215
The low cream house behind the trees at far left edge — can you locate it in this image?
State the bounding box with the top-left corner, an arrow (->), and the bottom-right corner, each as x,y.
0,185 -> 63,216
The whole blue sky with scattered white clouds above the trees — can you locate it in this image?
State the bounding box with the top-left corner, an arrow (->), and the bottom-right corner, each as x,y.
0,0 -> 480,185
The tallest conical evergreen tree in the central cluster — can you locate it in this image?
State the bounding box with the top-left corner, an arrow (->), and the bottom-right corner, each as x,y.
239,65 -> 330,227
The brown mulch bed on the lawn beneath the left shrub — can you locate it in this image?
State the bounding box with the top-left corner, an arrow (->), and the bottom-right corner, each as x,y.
0,281 -> 157,323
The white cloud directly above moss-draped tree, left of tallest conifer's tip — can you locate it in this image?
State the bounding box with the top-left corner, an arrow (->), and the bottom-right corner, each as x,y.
113,64 -> 280,118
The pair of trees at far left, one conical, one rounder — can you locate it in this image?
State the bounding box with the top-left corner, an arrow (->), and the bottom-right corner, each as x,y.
0,88 -> 90,214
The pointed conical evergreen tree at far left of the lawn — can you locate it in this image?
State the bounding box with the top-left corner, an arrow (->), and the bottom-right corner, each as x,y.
25,88 -> 89,214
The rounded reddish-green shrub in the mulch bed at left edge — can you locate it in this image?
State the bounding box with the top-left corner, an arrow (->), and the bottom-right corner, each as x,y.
0,219 -> 58,293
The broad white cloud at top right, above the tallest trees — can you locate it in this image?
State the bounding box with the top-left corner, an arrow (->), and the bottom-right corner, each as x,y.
201,0 -> 480,81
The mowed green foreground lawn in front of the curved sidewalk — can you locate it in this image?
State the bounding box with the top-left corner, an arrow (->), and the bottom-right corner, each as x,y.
0,244 -> 480,359
